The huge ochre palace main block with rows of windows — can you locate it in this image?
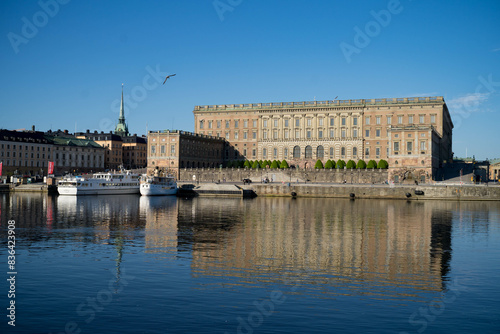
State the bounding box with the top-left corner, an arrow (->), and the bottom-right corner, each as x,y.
193,96 -> 453,182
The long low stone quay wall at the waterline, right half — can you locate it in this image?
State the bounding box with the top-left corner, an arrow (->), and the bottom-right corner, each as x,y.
247,183 -> 500,201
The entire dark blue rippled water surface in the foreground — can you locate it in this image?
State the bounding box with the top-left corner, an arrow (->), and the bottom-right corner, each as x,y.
0,194 -> 500,333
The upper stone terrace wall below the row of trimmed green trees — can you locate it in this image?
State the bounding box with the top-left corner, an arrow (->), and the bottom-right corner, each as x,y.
179,168 -> 388,184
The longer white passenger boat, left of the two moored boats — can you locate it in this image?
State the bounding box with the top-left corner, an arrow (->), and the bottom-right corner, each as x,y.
57,171 -> 140,196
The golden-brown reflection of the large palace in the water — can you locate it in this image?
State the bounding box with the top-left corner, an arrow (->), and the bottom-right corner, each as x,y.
179,198 -> 464,291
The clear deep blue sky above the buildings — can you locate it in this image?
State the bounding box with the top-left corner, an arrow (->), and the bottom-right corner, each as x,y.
0,0 -> 500,159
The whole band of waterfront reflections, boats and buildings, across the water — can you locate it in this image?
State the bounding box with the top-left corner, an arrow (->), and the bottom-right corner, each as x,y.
0,193 -> 498,295
